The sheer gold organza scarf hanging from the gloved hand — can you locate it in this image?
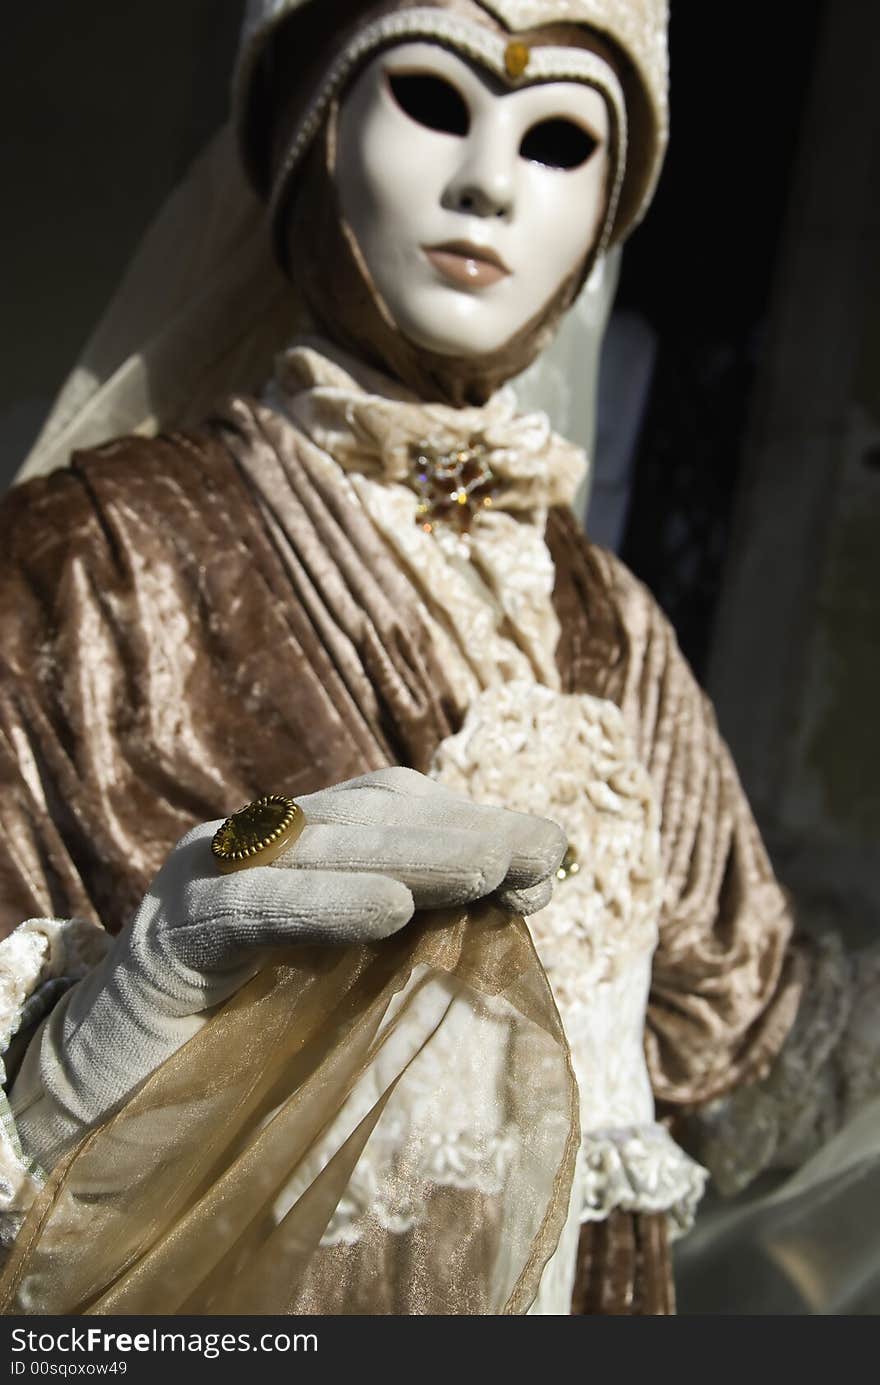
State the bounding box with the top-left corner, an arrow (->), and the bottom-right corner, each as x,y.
0,907 -> 578,1314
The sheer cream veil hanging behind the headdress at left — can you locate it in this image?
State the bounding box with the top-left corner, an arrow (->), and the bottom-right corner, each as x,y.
15,126 -> 310,482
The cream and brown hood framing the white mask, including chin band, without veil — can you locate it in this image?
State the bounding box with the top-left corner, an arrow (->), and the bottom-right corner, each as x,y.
234,0 -> 667,406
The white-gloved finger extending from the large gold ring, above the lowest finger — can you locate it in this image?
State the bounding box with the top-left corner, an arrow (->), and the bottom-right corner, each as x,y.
273,824 -> 510,909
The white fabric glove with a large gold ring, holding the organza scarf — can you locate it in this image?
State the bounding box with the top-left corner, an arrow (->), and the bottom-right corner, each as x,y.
11,767 -> 565,1170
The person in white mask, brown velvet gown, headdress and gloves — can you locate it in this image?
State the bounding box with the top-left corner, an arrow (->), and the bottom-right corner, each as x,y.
0,0 -> 877,1313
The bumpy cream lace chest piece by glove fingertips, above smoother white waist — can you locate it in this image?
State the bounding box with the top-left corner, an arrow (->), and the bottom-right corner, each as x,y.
432,680 -> 661,980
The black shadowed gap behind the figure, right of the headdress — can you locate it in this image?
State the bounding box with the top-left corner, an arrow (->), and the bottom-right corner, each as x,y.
617,0 -> 823,674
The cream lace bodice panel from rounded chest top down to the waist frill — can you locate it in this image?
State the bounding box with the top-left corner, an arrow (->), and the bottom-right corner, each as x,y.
432,681 -> 661,1132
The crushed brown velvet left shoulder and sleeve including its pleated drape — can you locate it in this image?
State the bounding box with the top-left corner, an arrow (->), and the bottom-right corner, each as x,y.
0,397 -> 465,936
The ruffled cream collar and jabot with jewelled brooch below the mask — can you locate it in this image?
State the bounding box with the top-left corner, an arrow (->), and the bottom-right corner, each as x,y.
266,339 -> 586,692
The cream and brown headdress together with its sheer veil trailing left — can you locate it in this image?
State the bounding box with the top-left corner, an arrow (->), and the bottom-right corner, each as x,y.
18,0 -> 668,479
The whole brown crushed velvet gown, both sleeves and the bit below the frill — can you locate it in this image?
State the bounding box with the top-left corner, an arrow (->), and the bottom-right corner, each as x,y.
0,399 -> 801,1313
